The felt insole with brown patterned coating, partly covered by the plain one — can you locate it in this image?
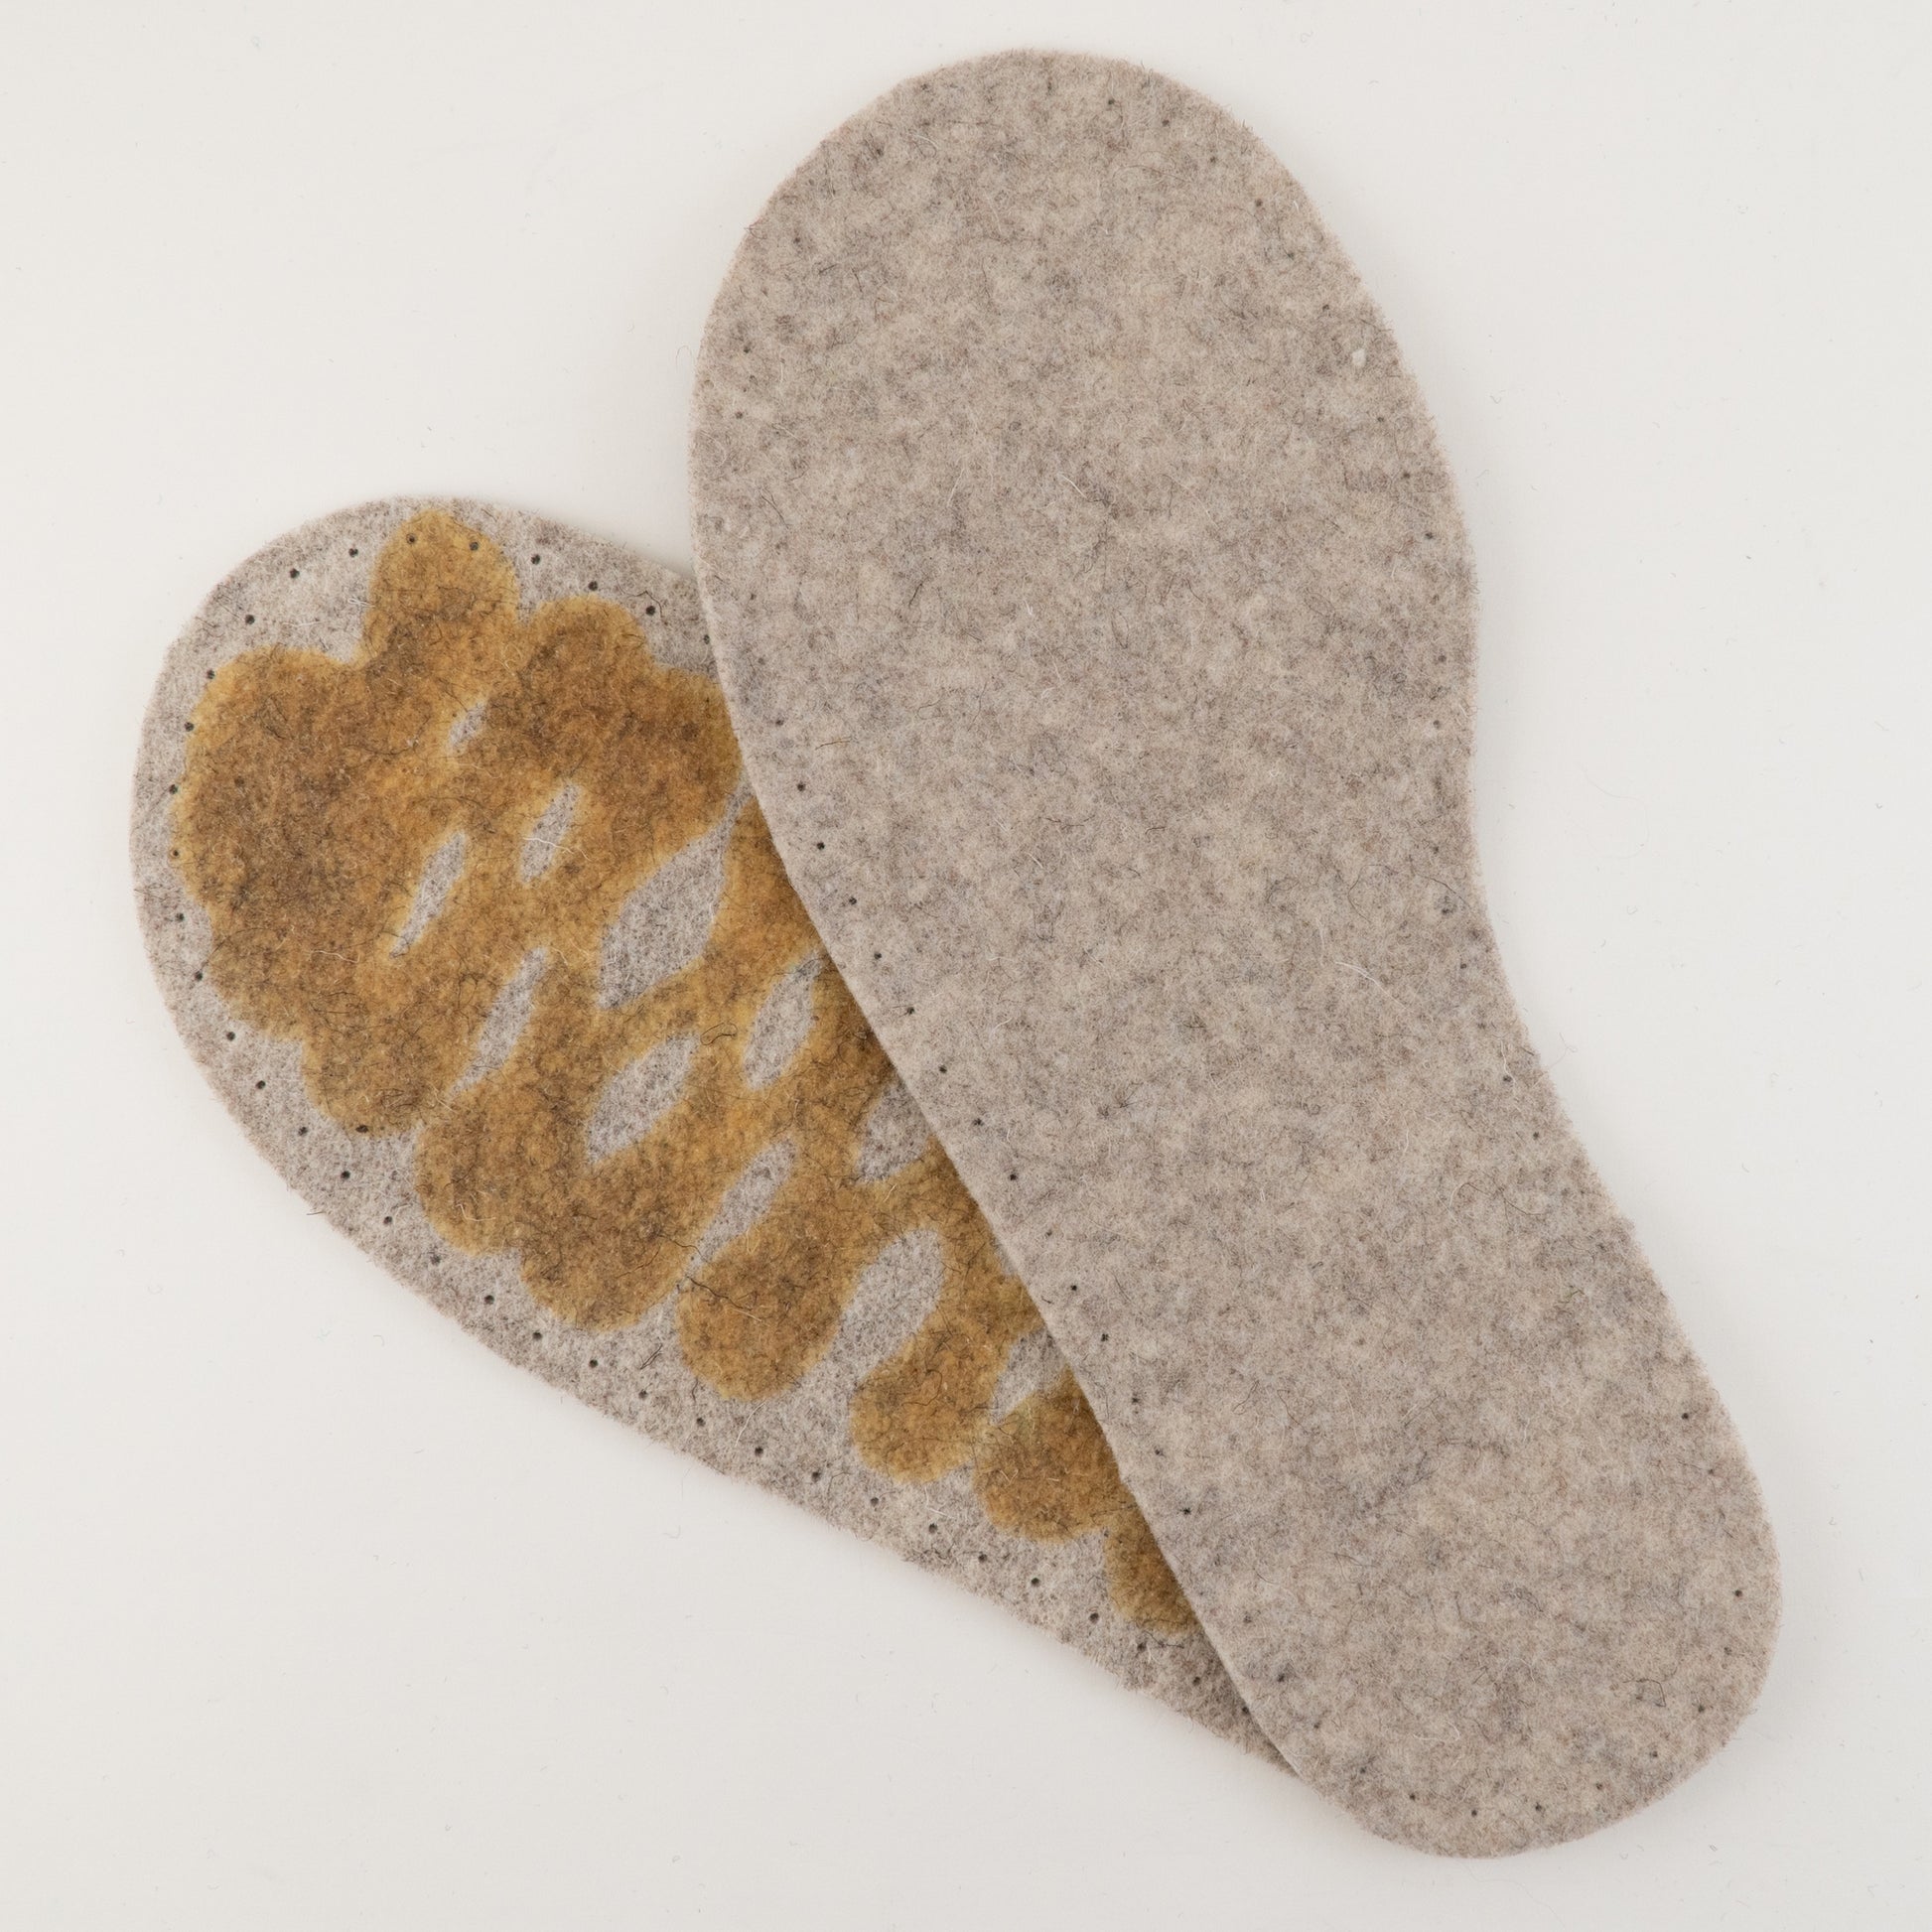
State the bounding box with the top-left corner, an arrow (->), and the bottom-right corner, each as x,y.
133,502 -> 1271,1756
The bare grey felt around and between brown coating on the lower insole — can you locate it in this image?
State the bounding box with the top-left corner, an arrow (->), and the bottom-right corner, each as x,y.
131,500 -> 1273,1758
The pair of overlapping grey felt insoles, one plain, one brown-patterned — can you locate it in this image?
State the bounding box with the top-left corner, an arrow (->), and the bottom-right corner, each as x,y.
135,54 -> 1777,1853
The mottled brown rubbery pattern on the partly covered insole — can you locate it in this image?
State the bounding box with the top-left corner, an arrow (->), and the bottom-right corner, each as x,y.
172,512 -> 1190,1630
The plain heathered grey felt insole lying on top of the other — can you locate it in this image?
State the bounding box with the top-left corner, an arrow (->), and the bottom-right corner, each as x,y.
692,53 -> 1777,1853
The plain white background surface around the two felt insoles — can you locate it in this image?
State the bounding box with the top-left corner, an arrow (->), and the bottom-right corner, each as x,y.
0,0 -> 1932,1932
